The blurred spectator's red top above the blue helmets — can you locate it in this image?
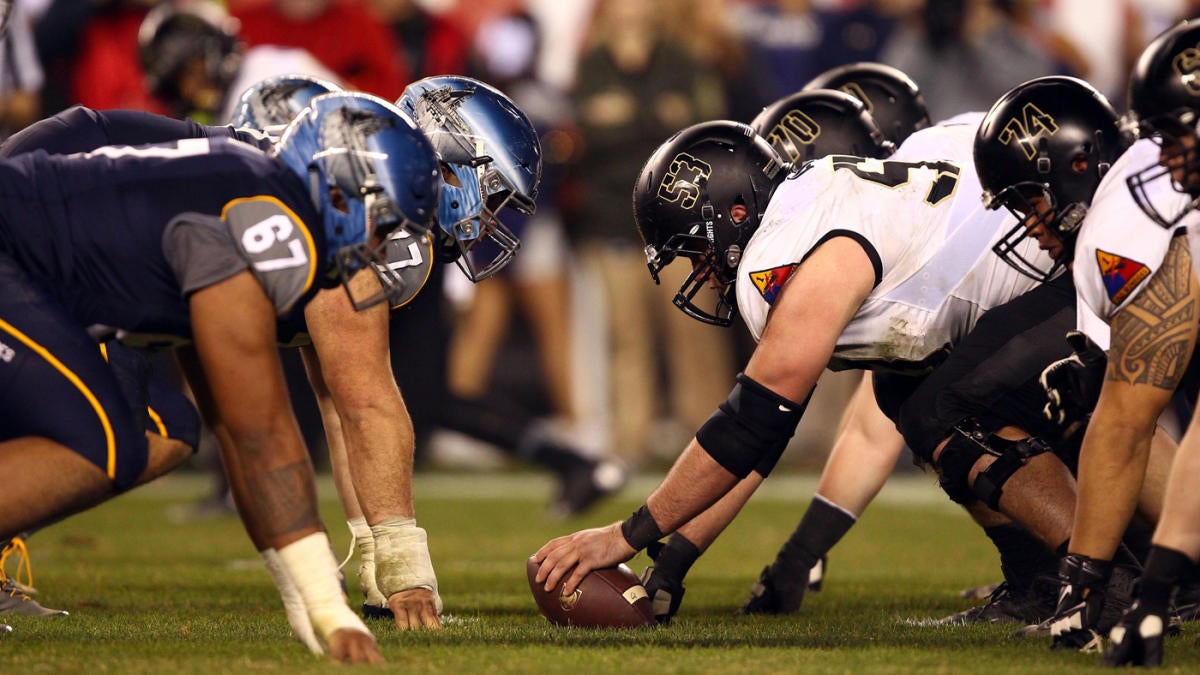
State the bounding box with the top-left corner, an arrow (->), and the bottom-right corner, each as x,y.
230,0 -> 410,101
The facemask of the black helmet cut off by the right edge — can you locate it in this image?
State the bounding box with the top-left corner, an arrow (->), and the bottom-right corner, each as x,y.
1126,110 -> 1200,228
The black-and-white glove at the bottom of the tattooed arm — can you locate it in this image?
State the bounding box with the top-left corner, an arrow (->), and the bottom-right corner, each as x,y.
1046,555 -> 1112,652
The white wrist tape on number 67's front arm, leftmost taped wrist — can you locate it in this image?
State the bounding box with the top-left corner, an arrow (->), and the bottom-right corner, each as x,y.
278,532 -> 371,644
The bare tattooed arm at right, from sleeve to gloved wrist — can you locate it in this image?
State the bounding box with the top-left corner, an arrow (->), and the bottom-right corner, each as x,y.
1070,237 -> 1200,560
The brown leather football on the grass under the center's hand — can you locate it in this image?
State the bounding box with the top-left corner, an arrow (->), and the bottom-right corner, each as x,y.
526,557 -> 655,628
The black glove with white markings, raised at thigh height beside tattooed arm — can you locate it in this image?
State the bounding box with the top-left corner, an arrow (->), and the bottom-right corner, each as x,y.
1042,330 -> 1109,426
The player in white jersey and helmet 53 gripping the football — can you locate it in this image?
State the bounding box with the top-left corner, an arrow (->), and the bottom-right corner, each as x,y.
535,114 -> 1056,592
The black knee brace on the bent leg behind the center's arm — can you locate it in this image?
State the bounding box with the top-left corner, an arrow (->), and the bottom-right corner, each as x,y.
937,419 -> 1051,510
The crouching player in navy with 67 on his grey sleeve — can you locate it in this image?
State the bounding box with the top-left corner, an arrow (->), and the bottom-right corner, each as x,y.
0,94 -> 440,662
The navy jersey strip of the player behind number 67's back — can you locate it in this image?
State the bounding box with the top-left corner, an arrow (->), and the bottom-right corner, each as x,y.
0,106 -> 271,157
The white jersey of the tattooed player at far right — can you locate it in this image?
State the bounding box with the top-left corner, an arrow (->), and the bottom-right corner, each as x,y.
1074,139 -> 1198,346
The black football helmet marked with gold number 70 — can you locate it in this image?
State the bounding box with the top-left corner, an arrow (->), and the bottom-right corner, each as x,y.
750,89 -> 895,166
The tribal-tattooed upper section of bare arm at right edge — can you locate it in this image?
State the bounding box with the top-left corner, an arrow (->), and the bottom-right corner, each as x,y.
1106,237 -> 1200,390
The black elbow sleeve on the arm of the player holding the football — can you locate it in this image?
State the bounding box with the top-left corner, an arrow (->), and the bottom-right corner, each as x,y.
696,372 -> 808,478
